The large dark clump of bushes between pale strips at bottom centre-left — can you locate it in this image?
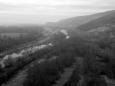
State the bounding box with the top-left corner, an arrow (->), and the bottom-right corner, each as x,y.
24,57 -> 75,86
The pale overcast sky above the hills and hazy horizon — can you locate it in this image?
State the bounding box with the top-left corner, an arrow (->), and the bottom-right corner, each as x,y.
0,0 -> 115,25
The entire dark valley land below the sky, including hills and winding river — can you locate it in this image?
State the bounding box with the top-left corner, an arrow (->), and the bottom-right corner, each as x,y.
0,10 -> 115,86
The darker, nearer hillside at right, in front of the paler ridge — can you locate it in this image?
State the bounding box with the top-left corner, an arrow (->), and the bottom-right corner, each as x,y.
76,11 -> 115,31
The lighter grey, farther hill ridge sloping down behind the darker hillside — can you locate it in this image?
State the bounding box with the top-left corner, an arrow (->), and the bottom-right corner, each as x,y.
46,10 -> 115,29
